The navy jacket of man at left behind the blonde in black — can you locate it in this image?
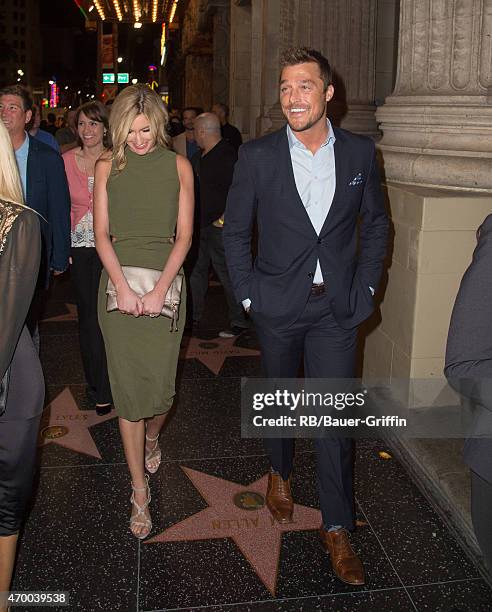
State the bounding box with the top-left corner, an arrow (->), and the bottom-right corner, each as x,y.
26,136 -> 70,280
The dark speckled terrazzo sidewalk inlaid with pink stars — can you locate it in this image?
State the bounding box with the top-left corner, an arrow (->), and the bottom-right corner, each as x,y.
13,278 -> 492,612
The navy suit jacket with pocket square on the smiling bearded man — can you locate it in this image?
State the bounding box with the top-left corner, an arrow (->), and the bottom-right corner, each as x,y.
224,128 -> 388,329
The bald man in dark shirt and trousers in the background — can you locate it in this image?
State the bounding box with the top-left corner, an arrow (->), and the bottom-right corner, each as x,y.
190,113 -> 249,338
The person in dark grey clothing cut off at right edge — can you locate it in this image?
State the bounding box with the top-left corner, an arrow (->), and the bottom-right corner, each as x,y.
444,215 -> 492,571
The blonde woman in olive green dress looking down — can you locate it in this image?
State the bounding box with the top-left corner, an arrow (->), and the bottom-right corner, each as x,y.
94,84 -> 194,538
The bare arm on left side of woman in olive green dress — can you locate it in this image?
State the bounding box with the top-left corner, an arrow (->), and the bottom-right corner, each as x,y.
94,158 -> 142,316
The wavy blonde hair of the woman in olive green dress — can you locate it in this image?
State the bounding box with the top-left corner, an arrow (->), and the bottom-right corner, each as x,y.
109,83 -> 171,171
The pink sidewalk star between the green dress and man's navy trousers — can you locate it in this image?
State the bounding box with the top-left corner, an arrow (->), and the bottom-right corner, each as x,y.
180,336 -> 260,375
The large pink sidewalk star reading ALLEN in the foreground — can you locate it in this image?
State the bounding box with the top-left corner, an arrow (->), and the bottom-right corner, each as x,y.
145,467 -> 321,595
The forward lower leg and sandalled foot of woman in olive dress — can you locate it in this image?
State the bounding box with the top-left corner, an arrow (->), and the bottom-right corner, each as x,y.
118,417 -> 150,537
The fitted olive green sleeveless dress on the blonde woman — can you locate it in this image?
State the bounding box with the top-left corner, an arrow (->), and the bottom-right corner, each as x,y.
98,147 -> 186,421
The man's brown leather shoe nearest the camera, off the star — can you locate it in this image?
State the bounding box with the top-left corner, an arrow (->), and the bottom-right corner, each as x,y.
319,527 -> 365,585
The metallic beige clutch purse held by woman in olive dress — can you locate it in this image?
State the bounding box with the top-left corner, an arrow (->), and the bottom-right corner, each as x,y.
106,266 -> 183,331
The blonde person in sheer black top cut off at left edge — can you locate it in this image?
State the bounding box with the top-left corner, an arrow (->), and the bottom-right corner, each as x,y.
0,123 -> 44,611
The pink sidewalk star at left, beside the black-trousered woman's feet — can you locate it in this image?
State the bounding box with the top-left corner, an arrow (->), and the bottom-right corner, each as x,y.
39,387 -> 116,459
